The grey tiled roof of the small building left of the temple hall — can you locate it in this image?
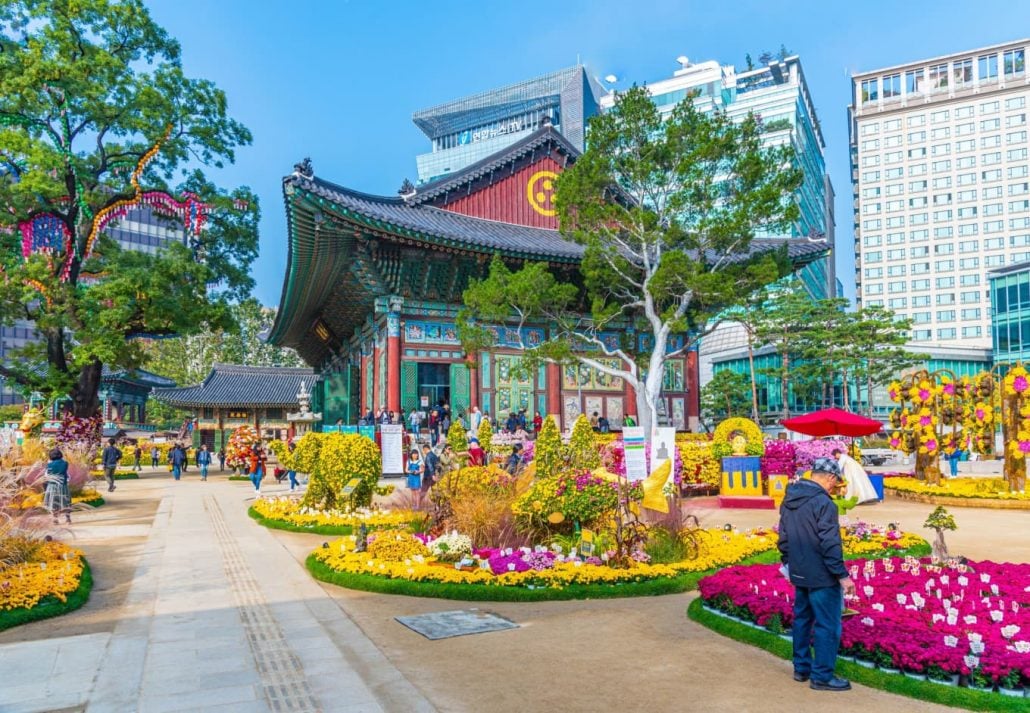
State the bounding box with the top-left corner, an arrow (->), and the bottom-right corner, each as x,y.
153,364 -> 315,408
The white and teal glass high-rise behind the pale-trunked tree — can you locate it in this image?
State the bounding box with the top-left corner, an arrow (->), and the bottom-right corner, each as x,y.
600,56 -> 836,298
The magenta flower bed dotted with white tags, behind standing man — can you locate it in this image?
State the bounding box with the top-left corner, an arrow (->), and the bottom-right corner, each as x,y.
698,557 -> 1030,688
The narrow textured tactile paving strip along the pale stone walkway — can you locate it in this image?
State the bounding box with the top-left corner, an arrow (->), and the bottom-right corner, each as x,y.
204,496 -> 321,713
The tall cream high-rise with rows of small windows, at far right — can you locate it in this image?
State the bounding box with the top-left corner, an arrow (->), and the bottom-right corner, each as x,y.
849,40 -> 1030,350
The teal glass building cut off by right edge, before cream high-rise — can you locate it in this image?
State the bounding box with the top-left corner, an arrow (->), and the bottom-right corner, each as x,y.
988,261 -> 1030,363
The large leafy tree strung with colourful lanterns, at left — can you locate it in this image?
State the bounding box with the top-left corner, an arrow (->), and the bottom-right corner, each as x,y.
0,0 -> 259,416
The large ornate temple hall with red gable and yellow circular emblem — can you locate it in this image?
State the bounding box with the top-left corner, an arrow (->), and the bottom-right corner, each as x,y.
269,118 -> 828,430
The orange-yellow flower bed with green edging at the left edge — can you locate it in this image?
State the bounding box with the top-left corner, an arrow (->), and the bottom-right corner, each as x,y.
0,542 -> 92,631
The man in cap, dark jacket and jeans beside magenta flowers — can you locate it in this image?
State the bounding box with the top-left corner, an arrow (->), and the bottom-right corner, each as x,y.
779,459 -> 855,690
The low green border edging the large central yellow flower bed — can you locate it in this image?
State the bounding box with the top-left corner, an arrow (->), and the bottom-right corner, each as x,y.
300,544 -> 930,602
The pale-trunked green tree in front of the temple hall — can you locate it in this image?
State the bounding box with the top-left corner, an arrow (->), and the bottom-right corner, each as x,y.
459,87 -> 801,433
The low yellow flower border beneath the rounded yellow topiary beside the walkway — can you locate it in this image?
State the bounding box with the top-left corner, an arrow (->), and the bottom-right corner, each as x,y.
250,498 -> 416,535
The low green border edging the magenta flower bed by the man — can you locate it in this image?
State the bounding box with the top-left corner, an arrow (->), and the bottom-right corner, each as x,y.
687,597 -> 1030,713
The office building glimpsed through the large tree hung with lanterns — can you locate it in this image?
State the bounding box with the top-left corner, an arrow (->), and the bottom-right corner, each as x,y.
0,206 -> 185,405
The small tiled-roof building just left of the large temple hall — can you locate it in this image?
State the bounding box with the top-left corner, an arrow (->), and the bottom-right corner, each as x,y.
153,364 -> 315,450
